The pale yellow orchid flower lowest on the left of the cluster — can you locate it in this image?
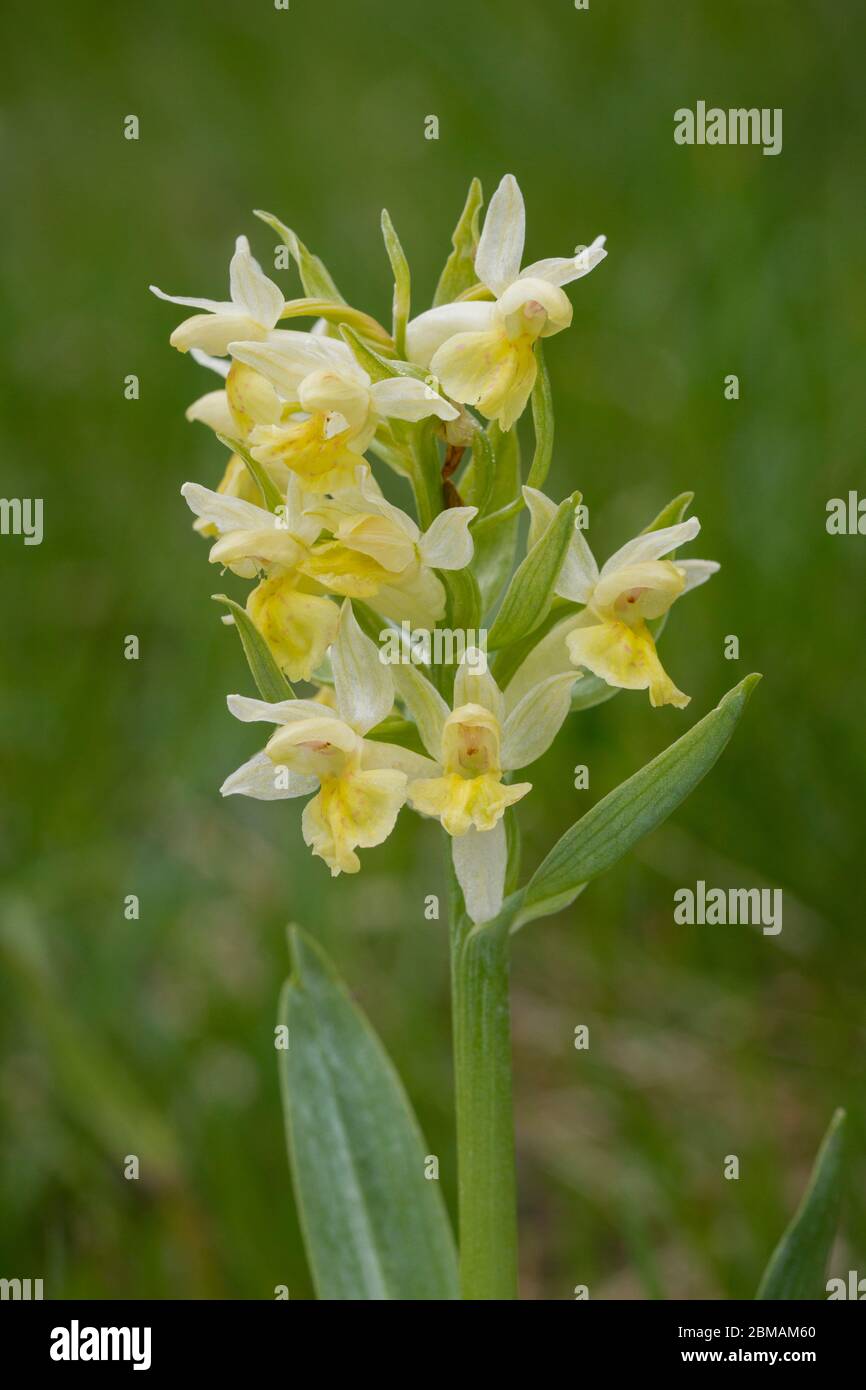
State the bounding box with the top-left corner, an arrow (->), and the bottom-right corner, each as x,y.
222,603 -> 435,874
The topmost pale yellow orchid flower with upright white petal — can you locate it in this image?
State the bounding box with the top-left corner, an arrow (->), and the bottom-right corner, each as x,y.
407,174 -> 607,430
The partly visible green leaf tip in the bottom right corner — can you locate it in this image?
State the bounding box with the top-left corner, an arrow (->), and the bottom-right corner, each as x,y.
755,1109 -> 845,1300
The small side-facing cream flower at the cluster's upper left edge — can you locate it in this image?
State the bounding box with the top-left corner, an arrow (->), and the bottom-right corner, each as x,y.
150,236 -> 285,356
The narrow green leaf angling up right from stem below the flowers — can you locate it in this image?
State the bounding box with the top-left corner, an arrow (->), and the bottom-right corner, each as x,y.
521,674 -> 760,922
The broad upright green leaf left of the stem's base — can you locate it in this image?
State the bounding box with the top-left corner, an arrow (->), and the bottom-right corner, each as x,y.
278,927 -> 459,1301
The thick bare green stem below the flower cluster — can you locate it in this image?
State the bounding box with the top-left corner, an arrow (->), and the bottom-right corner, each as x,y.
452,910 -> 517,1300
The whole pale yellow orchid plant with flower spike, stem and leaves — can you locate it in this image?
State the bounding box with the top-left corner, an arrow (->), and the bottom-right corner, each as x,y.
154,175 -> 839,1298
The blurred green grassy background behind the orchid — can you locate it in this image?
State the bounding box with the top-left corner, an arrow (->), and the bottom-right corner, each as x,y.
0,0 -> 866,1300
